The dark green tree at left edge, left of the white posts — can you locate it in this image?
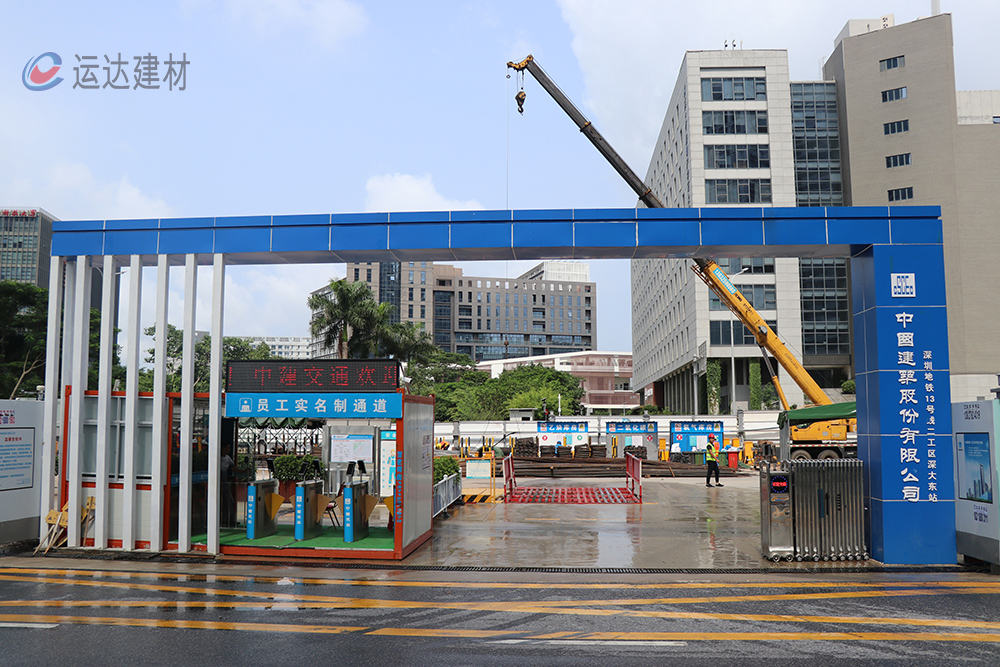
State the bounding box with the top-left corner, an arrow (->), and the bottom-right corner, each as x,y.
0,280 -> 48,398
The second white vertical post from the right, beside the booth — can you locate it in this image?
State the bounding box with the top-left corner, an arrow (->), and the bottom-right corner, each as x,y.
178,255 -> 198,551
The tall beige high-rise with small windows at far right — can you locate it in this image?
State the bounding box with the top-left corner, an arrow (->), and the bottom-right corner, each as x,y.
824,14 -> 1000,401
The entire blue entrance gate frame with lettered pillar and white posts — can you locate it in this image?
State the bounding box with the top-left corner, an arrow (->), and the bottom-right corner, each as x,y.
40,206 -> 956,564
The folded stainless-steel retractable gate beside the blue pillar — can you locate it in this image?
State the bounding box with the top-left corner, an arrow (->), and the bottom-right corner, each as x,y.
761,459 -> 868,561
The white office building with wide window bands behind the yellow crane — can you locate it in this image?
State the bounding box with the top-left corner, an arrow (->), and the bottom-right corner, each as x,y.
632,50 -> 812,413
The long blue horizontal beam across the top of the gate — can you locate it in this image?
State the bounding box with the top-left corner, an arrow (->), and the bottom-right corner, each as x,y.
52,206 -> 942,265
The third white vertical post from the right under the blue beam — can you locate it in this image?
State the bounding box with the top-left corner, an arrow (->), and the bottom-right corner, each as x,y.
149,255 -> 169,551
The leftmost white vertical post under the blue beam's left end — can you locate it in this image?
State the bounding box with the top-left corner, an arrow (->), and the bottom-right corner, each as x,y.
38,257 -> 65,539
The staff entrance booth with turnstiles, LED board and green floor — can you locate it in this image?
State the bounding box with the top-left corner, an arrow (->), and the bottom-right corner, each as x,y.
220,359 -> 434,559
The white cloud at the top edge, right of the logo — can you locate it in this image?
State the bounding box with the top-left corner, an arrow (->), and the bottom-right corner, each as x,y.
226,0 -> 368,48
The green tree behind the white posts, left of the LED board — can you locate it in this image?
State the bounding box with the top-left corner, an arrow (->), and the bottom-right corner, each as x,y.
139,324 -> 281,392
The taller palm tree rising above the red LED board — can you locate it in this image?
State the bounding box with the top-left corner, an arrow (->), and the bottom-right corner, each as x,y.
308,278 -> 380,359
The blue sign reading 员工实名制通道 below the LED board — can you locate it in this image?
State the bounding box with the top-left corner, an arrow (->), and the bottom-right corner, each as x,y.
226,392 -> 403,419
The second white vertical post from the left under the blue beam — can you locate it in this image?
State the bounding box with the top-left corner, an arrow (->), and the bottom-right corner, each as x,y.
66,255 -> 90,547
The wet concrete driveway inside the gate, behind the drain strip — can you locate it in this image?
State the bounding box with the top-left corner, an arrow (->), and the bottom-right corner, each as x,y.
404,475 -> 771,569
